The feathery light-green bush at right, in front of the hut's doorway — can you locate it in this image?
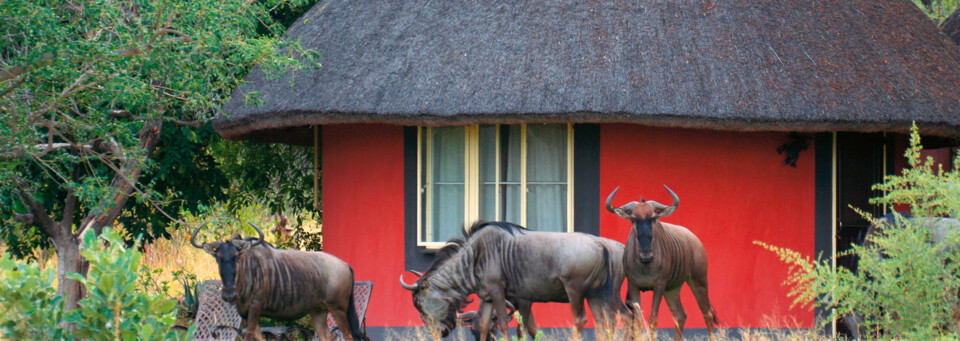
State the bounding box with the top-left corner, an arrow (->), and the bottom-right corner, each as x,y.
754,126 -> 960,339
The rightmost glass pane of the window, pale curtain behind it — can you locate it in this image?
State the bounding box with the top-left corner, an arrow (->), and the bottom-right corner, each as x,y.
526,124 -> 567,231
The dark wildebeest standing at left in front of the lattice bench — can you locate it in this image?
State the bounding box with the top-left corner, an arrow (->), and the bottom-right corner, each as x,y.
190,224 -> 366,340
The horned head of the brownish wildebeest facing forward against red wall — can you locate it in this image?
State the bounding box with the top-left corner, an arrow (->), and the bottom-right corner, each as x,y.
606,185 -> 680,263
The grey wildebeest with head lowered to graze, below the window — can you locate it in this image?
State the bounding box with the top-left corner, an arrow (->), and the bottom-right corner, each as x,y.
400,222 -> 623,340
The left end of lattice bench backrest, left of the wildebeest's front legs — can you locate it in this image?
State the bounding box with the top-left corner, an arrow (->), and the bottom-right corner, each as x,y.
193,280 -> 242,341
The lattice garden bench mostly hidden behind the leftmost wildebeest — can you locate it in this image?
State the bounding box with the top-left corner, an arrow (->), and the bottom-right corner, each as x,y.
193,280 -> 373,341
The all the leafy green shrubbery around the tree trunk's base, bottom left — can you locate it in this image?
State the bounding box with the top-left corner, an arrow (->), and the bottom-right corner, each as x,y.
0,228 -> 192,340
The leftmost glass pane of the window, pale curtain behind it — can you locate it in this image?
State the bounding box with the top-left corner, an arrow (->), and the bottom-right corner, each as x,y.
427,127 -> 466,242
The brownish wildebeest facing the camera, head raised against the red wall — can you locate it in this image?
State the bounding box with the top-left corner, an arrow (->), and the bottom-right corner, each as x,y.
606,185 -> 717,340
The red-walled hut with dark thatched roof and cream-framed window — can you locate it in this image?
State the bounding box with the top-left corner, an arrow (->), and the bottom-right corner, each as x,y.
214,0 -> 960,334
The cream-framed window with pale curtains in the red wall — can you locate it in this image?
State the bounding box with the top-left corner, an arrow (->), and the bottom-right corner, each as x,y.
417,124 -> 573,247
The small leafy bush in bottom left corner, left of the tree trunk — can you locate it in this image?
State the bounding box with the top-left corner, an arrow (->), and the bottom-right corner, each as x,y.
0,253 -> 66,340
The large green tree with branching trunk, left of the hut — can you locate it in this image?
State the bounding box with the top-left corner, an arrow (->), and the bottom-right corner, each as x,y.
0,0 -> 319,310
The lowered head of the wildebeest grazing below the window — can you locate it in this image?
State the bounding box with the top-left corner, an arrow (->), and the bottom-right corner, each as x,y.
400,271 -> 461,337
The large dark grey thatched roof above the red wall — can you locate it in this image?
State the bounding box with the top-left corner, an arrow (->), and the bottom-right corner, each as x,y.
214,0 -> 960,142
